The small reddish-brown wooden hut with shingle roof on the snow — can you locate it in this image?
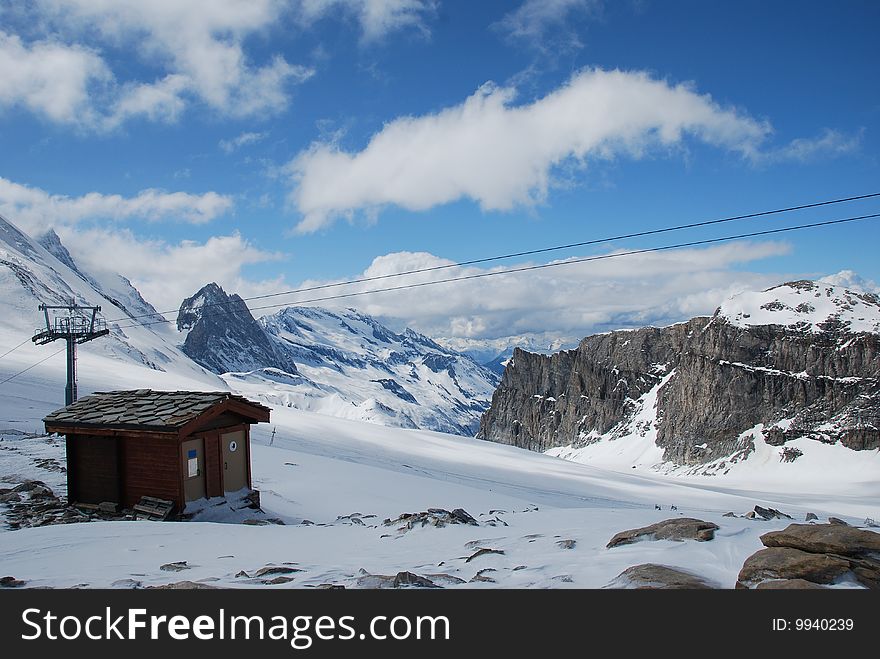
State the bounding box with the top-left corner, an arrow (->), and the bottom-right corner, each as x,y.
43,389 -> 269,512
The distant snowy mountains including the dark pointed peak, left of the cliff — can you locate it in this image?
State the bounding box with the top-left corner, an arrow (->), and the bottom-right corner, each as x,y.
178,284 -> 498,436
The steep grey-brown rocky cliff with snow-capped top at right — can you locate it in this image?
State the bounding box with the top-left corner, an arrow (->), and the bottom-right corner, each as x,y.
478,281 -> 880,464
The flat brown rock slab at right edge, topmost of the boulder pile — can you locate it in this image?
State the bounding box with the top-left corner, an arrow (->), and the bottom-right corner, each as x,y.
761,524 -> 880,557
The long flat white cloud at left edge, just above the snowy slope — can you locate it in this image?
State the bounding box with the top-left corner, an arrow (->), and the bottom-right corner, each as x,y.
0,177 -> 233,235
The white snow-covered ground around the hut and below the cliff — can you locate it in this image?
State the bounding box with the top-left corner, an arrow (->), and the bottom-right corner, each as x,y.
0,404 -> 880,588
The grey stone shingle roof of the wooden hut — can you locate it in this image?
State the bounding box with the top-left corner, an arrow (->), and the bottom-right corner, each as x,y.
43,389 -> 268,430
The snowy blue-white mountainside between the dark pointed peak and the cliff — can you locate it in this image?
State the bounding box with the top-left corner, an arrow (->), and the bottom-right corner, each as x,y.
234,307 -> 498,436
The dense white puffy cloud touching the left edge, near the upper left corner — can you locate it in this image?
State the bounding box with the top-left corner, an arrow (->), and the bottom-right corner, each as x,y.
0,31 -> 112,125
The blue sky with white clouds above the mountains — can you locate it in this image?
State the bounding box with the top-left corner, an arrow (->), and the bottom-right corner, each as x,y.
0,0 -> 880,346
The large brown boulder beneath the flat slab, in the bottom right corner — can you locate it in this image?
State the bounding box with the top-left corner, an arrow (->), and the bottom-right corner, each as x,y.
736,547 -> 850,588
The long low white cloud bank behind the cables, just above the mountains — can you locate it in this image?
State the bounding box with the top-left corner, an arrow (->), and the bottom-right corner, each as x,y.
286,242 -> 791,339
